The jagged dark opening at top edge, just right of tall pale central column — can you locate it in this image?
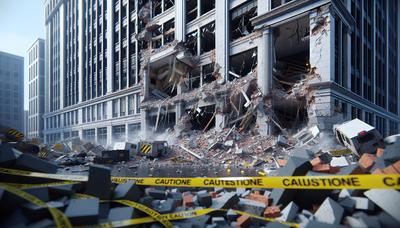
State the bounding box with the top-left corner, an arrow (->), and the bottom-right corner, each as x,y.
230,0 -> 257,41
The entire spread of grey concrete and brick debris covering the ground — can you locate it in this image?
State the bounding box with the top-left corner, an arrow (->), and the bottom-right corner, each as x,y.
0,114 -> 400,227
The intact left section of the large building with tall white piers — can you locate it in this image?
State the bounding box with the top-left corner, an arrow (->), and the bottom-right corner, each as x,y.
44,0 -> 141,144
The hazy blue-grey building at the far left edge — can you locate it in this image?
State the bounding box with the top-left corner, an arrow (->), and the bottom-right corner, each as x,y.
0,51 -> 24,132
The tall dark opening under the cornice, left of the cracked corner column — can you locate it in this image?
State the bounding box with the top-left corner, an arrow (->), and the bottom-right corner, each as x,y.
272,17 -> 311,129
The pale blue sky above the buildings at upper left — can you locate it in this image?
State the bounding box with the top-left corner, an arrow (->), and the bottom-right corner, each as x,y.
0,0 -> 45,110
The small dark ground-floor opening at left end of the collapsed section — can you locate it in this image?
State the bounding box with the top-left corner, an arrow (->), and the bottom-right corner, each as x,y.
149,110 -> 175,133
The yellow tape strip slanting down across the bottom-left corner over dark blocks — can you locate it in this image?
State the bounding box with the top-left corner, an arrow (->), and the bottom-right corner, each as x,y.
0,183 -> 72,228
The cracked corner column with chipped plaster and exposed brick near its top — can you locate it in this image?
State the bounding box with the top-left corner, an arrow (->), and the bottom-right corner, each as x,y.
310,6 -> 335,83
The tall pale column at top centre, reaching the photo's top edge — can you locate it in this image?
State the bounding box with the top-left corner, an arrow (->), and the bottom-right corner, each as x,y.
215,0 -> 229,82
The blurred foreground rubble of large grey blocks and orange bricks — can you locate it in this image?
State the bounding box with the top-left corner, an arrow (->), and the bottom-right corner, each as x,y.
0,134 -> 400,227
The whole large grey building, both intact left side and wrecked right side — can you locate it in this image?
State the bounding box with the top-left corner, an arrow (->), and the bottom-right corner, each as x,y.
45,0 -> 400,145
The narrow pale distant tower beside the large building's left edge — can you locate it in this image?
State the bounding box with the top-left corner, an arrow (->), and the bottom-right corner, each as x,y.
27,39 -> 45,139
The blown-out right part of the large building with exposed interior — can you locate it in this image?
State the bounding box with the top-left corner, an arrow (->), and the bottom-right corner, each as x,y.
138,0 -> 400,139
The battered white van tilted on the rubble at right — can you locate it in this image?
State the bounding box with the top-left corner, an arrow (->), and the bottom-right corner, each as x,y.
333,119 -> 383,156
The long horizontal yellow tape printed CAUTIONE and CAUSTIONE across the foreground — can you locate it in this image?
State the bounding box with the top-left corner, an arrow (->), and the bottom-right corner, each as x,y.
0,168 -> 400,189
